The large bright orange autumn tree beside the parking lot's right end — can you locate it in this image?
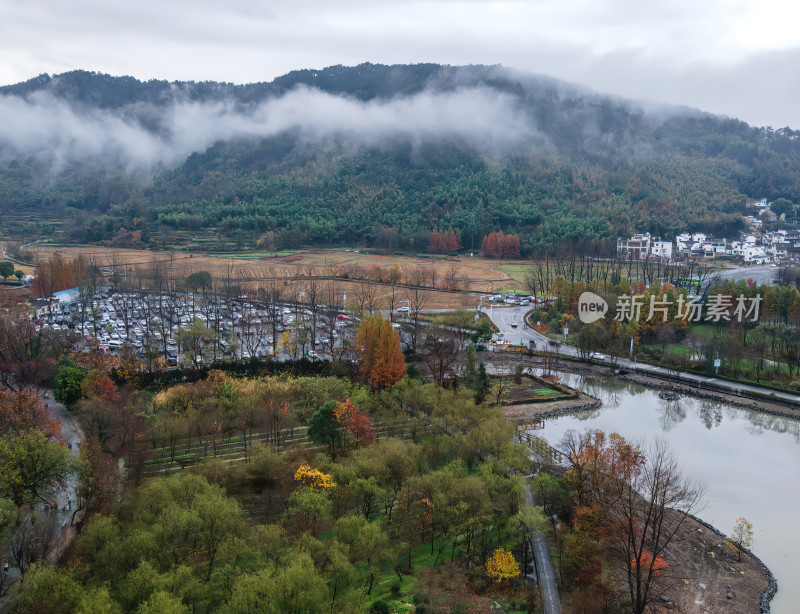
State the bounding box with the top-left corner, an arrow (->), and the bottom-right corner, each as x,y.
355,316 -> 406,390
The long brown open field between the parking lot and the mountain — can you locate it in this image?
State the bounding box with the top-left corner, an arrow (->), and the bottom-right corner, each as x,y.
29,245 -> 525,309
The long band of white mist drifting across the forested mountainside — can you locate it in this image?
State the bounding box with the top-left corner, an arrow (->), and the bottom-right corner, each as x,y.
0,88 -> 536,170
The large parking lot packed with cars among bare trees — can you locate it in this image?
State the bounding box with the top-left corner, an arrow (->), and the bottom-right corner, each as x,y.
39,291 -> 357,367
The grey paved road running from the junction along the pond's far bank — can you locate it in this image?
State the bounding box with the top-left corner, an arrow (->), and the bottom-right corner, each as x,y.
484,306 -> 800,405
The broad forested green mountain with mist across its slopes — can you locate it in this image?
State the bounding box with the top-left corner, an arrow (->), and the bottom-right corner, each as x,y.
0,64 -> 800,252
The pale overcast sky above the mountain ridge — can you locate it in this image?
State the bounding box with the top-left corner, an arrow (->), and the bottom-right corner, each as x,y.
0,0 -> 800,129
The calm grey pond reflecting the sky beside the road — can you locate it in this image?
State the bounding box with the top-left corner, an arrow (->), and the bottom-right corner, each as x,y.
534,370 -> 800,614
